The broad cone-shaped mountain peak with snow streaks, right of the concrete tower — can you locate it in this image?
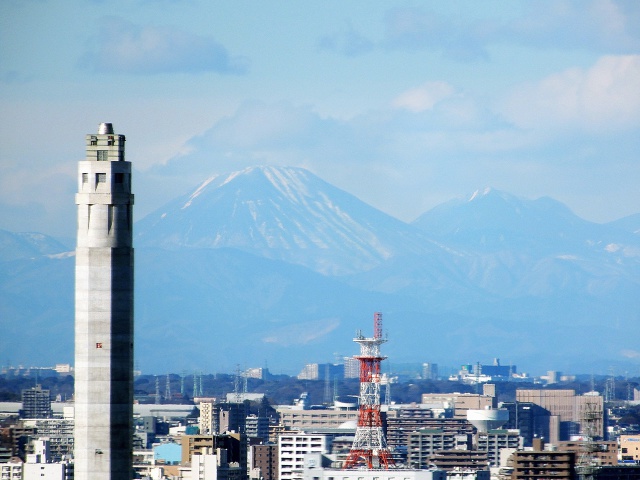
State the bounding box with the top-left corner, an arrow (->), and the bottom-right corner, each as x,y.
135,166 -> 435,274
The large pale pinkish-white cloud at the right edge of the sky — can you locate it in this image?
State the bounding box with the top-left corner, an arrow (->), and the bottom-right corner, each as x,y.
502,55 -> 640,131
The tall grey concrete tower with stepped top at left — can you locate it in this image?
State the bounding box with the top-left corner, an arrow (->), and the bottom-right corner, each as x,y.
74,123 -> 133,480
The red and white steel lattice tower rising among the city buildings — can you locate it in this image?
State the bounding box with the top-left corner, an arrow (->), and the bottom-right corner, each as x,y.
343,313 -> 393,469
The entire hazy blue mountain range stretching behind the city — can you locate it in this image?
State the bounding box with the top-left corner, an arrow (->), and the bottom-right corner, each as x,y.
0,167 -> 640,373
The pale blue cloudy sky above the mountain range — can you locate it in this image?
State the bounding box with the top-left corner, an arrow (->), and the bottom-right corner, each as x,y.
0,0 -> 640,238
